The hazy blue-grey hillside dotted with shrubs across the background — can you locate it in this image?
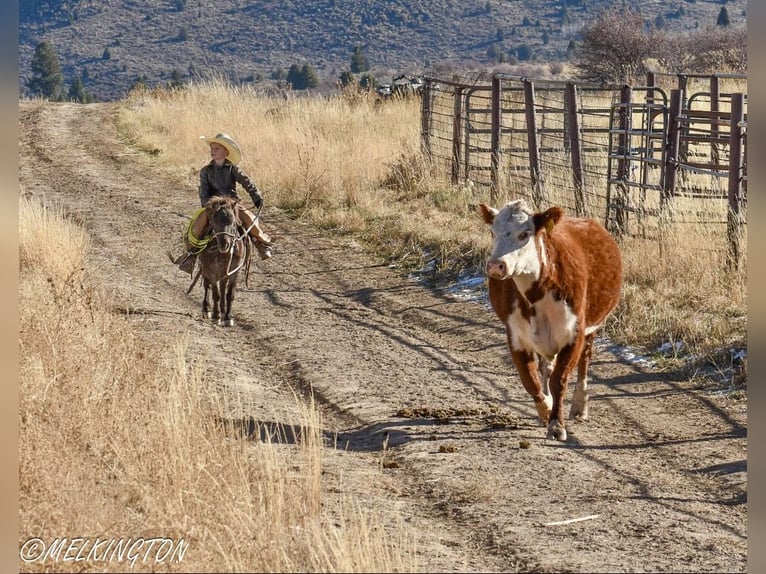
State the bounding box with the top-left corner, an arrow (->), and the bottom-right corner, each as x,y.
19,0 -> 747,100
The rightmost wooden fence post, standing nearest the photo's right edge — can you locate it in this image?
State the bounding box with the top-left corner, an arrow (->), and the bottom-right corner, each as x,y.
726,94 -> 745,269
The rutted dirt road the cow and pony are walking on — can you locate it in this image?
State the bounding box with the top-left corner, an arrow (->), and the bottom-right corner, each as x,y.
19,102 -> 747,572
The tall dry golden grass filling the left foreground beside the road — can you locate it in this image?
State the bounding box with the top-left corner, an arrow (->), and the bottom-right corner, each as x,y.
19,199 -> 416,572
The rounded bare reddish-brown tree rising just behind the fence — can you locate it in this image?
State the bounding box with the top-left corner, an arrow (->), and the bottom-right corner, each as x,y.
577,10 -> 654,84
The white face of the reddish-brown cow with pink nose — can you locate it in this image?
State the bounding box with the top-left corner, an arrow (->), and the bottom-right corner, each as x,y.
485,200 -> 544,280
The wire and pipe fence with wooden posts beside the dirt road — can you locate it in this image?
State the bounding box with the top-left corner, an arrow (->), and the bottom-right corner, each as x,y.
421,74 -> 747,265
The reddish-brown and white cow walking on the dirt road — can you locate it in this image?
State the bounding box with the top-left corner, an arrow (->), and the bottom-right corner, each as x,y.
479,200 -> 622,441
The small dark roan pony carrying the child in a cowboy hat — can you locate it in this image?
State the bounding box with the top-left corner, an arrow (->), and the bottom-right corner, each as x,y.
189,196 -> 252,327
